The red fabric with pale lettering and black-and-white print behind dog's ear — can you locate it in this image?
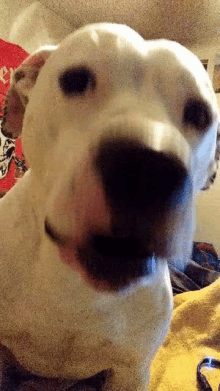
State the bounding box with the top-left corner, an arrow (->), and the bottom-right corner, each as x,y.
0,39 -> 28,197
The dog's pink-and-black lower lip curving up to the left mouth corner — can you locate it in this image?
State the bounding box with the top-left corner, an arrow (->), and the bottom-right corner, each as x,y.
45,220 -> 157,293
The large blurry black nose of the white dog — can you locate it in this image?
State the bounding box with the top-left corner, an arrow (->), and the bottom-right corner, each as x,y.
95,138 -> 189,213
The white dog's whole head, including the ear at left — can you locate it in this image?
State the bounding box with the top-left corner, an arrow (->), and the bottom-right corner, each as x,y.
3,24 -> 218,290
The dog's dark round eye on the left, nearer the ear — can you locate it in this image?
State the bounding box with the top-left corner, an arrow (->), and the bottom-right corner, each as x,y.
59,67 -> 96,96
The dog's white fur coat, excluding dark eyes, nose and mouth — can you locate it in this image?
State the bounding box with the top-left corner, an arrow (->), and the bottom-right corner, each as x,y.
0,24 -> 217,391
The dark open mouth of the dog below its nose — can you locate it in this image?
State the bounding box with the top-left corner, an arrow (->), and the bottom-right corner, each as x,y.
77,234 -> 156,290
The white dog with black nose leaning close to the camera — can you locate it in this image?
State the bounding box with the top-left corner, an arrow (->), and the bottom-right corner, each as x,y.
0,24 -> 218,391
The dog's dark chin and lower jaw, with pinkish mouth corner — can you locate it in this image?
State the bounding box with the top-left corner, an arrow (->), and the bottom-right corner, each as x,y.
45,221 -> 157,292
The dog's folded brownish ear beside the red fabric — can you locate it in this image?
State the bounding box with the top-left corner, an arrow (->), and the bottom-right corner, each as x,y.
1,46 -> 57,139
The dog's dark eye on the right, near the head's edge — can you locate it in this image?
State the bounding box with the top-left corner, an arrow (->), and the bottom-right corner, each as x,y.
183,98 -> 212,131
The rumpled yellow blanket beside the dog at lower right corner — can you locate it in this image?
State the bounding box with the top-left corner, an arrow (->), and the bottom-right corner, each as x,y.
150,278 -> 220,391
